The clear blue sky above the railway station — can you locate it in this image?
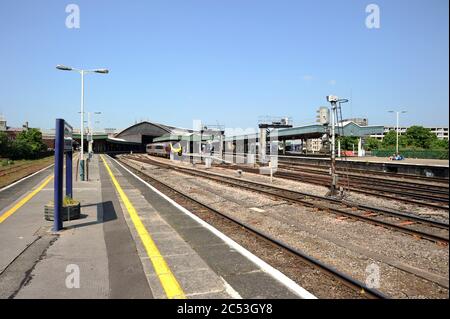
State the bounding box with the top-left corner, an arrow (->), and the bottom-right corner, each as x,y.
0,0 -> 449,128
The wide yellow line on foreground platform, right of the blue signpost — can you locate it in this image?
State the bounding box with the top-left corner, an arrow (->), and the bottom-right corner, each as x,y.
100,155 -> 186,299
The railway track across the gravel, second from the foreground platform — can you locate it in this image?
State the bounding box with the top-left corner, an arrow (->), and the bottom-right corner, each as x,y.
126,155 -> 449,245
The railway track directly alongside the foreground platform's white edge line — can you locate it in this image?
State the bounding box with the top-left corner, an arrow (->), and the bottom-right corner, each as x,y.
120,158 -> 388,299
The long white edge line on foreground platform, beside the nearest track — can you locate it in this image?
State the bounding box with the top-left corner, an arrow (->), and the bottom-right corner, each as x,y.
108,155 -> 317,299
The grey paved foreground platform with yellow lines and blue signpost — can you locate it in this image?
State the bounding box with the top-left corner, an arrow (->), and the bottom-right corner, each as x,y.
0,155 -> 314,299
